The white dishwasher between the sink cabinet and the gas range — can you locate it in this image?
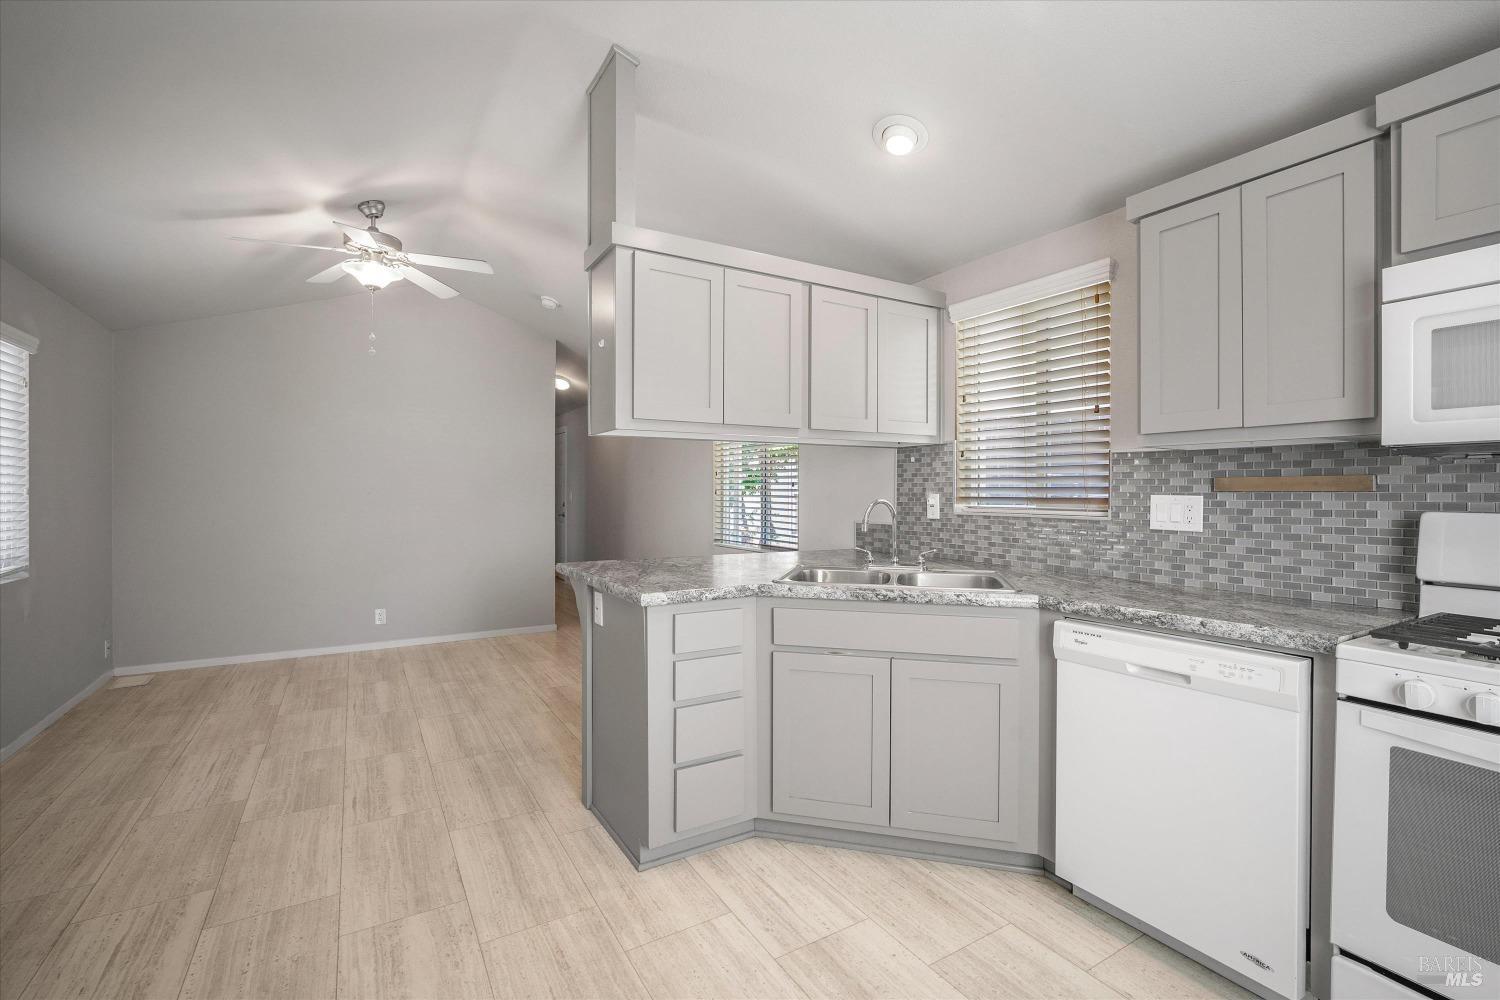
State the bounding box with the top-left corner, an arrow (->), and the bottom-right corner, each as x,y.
1053,621 -> 1311,1000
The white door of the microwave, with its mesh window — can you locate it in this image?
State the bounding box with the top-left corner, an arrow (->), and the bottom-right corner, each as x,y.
1380,285 -> 1500,445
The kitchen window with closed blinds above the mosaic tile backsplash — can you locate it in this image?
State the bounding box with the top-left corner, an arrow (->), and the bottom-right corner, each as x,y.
950,259 -> 1113,516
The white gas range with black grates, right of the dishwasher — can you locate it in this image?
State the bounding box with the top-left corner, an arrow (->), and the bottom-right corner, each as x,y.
1332,513 -> 1500,1000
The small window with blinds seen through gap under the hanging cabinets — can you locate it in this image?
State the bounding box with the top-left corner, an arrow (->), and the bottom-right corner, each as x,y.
714,441 -> 797,549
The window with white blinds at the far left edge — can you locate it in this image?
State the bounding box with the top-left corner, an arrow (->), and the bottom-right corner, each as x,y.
0,324 -> 36,583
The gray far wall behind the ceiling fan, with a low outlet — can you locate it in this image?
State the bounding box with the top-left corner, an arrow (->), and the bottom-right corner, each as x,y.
114,285 -> 555,667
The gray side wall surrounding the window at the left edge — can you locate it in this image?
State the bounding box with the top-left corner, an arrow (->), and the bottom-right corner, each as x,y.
0,261 -> 111,747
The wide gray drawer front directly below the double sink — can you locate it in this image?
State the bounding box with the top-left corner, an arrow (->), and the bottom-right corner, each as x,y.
771,607 -> 1020,660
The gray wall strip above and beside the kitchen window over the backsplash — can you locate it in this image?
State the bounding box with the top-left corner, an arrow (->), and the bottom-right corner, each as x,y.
923,208 -> 1140,451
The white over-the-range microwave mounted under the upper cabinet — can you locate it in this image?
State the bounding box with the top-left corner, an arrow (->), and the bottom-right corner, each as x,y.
1380,246 -> 1500,450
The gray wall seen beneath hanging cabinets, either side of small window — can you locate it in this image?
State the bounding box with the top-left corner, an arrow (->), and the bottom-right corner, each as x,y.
587,438 -> 896,559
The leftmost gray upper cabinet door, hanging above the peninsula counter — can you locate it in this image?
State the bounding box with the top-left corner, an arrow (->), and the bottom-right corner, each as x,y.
632,250 -> 725,424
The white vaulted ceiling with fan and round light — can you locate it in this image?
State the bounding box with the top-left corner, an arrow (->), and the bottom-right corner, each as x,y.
0,0 -> 1500,345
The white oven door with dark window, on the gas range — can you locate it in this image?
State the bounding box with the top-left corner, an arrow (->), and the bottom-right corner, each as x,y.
1332,702 -> 1500,1000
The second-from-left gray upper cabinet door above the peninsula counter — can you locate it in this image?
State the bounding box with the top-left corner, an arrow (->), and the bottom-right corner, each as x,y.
725,271 -> 807,427
